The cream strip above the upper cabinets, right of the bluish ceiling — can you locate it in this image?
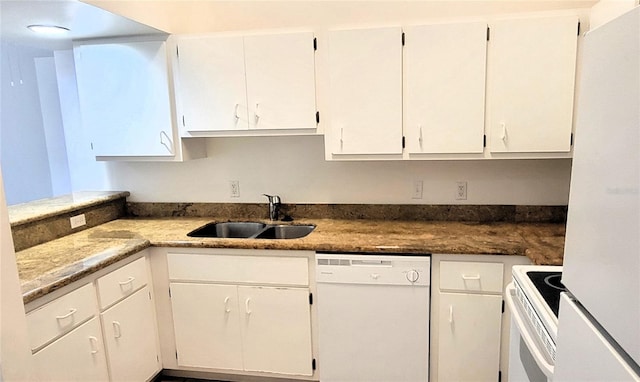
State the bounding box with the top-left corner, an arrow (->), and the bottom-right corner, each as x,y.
82,0 -> 597,34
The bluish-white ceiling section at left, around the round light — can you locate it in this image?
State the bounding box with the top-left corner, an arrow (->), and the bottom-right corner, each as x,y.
0,0 -> 164,50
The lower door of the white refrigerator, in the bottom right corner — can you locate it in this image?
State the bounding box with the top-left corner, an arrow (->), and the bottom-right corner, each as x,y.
553,293 -> 640,382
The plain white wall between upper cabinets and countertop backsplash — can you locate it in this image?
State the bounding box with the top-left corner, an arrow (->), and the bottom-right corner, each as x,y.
109,136 -> 571,205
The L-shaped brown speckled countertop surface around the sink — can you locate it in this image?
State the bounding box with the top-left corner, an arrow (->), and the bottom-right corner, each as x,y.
16,217 -> 565,303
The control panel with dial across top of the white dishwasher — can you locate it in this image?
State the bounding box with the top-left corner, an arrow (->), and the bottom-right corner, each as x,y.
316,253 -> 431,286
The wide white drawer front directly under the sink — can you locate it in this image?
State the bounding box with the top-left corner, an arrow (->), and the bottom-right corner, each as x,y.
167,253 -> 309,285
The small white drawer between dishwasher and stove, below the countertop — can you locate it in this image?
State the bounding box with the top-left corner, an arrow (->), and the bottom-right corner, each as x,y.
440,261 -> 503,293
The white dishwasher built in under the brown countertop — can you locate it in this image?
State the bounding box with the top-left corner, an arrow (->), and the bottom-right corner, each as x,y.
316,253 -> 431,382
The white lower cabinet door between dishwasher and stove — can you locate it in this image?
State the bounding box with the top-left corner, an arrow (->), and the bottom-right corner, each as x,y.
437,293 -> 502,382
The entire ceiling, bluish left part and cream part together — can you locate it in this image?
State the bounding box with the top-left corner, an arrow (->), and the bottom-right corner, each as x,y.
0,0 -> 596,50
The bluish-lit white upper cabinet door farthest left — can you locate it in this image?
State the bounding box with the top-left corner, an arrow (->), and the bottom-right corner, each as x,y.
74,41 -> 174,156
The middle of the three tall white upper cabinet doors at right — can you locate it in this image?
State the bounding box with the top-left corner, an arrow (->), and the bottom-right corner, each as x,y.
404,23 -> 487,153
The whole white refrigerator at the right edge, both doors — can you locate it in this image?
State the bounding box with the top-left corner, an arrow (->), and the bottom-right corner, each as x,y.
553,7 -> 640,382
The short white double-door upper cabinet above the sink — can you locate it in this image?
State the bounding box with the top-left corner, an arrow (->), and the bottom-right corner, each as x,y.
176,32 -> 316,136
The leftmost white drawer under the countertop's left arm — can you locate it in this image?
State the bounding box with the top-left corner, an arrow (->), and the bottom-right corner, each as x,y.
27,284 -> 97,350
